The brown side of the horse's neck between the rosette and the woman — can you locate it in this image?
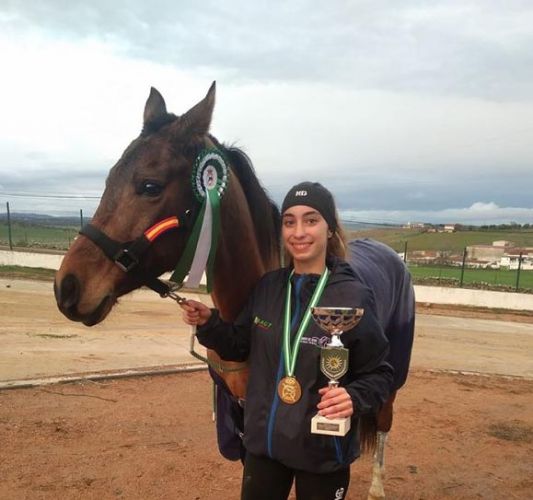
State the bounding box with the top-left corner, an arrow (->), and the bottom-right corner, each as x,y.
213,183 -> 271,321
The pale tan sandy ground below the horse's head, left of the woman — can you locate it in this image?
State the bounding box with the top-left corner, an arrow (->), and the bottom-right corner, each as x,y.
0,279 -> 209,387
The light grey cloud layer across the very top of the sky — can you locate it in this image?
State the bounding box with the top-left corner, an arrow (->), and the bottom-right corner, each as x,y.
3,0 -> 533,99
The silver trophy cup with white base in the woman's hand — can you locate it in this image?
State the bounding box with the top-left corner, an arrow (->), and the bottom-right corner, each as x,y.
311,307 -> 364,436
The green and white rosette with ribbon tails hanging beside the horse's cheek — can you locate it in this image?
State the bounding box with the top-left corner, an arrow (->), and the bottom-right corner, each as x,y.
170,148 -> 229,292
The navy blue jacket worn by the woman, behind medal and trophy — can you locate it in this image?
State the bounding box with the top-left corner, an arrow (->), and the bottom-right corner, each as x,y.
197,259 -> 393,473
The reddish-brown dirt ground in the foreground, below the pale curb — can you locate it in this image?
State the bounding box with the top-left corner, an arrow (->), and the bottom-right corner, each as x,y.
0,371 -> 533,500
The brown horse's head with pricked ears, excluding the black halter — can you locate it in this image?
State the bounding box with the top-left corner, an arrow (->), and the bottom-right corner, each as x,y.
54,83 -> 215,326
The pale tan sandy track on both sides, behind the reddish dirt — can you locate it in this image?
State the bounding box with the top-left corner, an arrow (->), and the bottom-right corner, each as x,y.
0,279 -> 533,387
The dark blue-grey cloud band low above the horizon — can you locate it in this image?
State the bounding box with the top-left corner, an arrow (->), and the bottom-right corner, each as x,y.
0,160 -> 533,223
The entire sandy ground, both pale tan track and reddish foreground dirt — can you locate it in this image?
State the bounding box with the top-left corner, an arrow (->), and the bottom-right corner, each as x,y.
0,280 -> 533,500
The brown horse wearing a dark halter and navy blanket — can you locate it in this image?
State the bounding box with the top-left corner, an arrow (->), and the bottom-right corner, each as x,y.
54,84 -> 414,498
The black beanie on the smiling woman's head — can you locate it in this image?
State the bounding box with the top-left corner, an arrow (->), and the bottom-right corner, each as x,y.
281,182 -> 337,231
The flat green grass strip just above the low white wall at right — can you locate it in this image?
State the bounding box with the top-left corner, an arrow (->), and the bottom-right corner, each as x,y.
409,265 -> 533,290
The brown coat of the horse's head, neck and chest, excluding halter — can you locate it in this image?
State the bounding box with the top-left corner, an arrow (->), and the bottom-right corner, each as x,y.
54,83 -> 279,397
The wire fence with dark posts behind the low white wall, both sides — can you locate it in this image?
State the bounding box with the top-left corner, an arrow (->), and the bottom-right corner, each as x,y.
0,202 -> 533,293
